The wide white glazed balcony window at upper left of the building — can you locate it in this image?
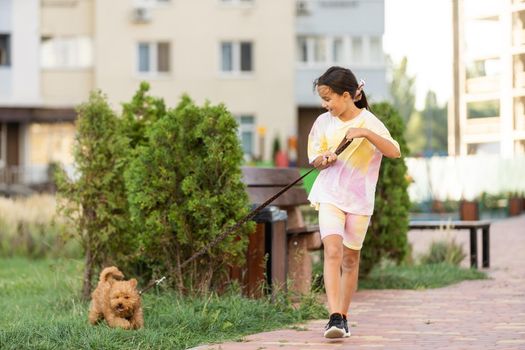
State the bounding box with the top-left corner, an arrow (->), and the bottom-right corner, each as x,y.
40,36 -> 93,68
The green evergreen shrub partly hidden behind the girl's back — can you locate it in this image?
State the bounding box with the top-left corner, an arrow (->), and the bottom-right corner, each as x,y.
360,103 -> 410,275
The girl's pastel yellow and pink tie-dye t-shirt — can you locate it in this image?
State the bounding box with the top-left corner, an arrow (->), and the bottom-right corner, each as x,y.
308,109 -> 399,215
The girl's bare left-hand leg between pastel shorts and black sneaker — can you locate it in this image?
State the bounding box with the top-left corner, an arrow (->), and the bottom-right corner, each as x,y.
323,234 -> 342,314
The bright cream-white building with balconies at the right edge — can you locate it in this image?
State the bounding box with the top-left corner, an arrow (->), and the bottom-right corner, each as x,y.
449,0 -> 525,158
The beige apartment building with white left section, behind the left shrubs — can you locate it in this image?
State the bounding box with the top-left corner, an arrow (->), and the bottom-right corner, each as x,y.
0,0 -> 297,186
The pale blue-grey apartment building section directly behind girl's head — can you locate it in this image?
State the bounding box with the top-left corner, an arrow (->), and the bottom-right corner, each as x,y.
295,0 -> 388,166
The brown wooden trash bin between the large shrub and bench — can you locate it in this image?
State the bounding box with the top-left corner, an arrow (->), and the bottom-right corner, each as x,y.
243,206 -> 288,297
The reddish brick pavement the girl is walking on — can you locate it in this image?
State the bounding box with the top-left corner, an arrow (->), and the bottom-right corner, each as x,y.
196,215 -> 525,350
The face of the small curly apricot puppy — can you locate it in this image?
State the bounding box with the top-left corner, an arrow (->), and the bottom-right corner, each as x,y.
109,279 -> 140,318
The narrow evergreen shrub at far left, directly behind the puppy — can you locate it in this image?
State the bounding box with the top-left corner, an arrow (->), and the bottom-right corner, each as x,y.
56,91 -> 130,299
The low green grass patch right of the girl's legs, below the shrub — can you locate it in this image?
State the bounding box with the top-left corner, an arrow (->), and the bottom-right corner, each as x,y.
359,263 -> 488,289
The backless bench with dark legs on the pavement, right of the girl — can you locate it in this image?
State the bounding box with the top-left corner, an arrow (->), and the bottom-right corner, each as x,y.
409,221 -> 490,268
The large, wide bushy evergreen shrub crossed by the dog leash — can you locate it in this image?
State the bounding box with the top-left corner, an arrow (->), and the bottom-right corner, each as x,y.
125,96 -> 253,292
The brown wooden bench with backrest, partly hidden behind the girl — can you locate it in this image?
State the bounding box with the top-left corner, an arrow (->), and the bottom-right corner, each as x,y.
242,167 -> 321,293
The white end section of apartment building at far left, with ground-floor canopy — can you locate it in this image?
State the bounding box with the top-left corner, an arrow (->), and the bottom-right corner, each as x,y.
0,0 -> 75,183
